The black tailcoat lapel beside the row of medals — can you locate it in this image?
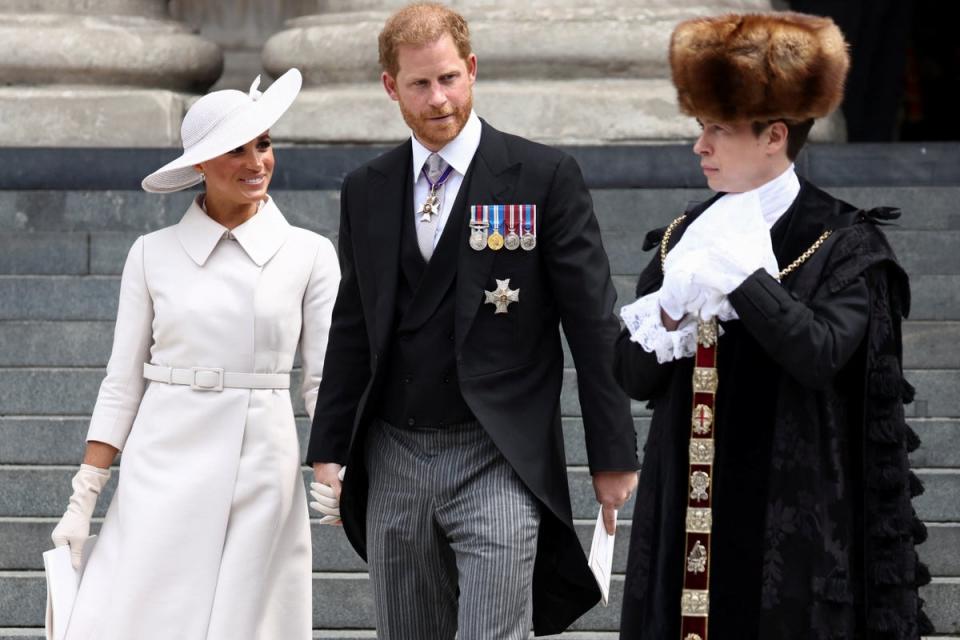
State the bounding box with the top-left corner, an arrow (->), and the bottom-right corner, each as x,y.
450,122 -> 521,352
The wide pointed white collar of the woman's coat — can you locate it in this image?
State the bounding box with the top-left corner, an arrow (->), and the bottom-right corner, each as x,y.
177,196 -> 290,267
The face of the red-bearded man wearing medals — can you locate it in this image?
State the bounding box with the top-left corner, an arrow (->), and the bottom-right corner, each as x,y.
382,34 -> 477,151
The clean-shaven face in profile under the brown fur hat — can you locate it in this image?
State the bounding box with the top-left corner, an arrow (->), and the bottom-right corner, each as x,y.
693,119 -> 789,193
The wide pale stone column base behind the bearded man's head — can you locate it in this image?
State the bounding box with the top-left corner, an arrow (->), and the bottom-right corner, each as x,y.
263,0 -> 837,144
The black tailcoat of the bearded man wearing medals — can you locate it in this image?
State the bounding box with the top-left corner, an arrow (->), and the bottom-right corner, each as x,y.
307,123 -> 639,634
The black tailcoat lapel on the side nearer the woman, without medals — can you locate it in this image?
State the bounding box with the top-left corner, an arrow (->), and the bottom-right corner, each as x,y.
367,141 -> 413,349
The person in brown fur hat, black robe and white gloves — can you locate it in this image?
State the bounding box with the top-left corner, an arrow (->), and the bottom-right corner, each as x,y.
615,13 -> 931,640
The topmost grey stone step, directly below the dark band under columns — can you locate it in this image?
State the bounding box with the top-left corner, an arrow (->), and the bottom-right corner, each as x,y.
0,186 -> 960,239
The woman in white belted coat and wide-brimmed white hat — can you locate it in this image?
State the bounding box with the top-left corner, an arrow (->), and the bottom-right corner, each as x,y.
53,69 -> 340,640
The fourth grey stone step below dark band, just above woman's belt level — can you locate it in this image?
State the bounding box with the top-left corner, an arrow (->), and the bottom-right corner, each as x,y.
7,320 -> 960,369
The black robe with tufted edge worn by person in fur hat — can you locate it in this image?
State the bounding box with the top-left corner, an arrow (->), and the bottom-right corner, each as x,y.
615,181 -> 930,640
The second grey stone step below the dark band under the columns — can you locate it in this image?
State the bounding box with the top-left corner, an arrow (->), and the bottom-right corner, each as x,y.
0,224 -> 960,275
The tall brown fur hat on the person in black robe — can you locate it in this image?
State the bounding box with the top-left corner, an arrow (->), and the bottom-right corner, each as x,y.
670,12 -> 850,122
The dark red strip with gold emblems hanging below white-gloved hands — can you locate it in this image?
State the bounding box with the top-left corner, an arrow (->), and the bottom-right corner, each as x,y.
680,318 -> 719,640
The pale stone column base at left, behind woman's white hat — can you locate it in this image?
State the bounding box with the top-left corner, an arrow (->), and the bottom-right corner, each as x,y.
0,0 -> 223,147
